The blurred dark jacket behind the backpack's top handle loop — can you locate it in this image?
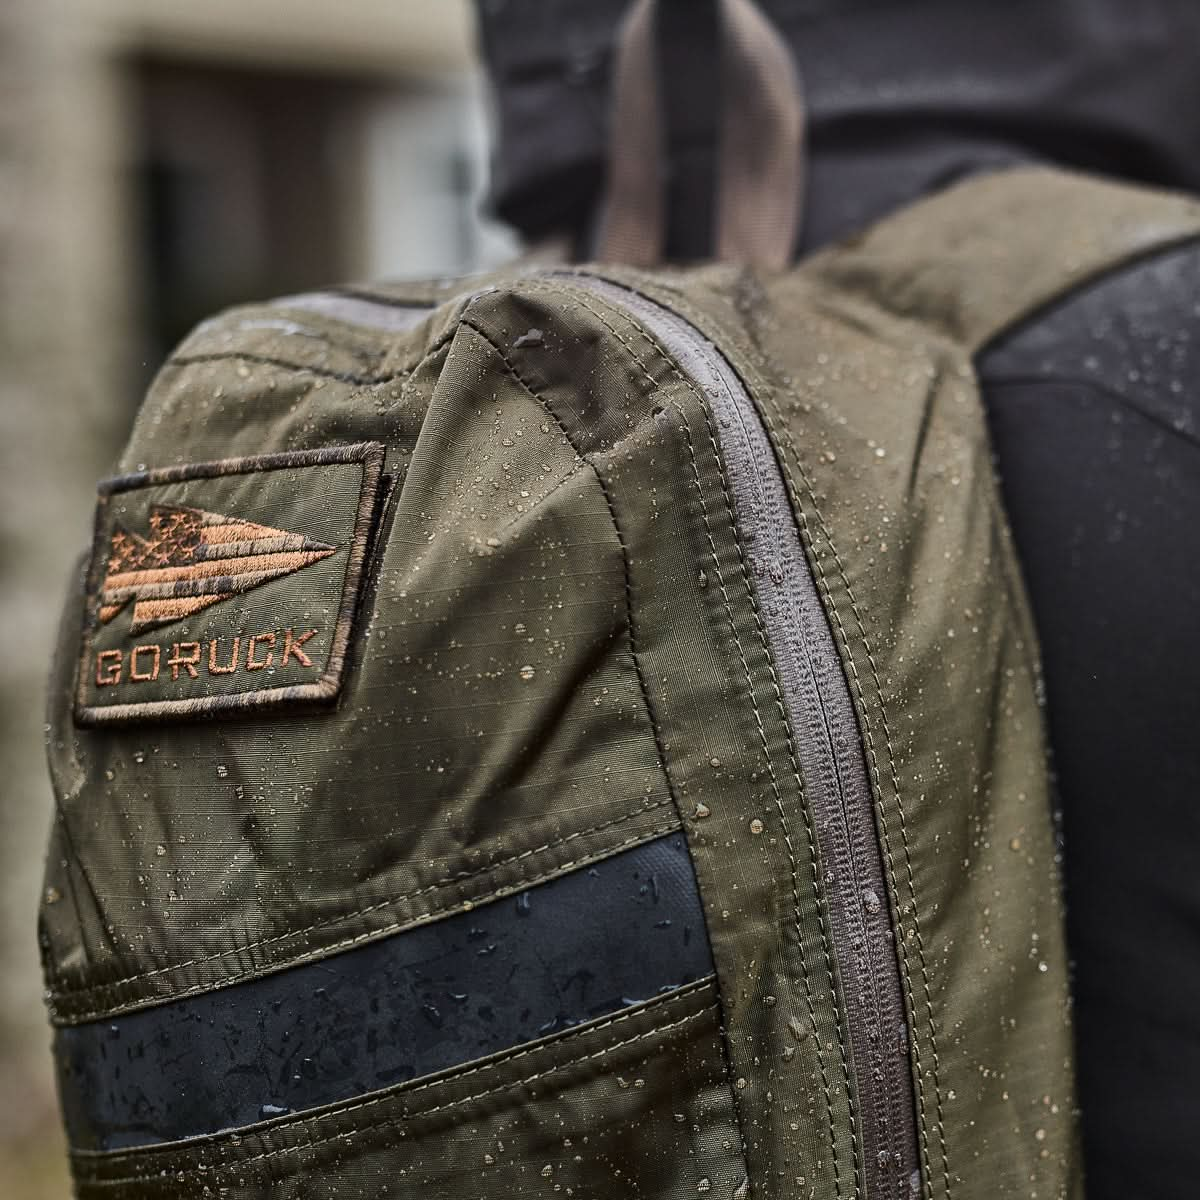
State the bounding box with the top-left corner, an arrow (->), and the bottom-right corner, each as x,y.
479,0 -> 1200,257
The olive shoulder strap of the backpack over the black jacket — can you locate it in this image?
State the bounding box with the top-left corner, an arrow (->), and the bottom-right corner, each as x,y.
806,168 -> 1200,353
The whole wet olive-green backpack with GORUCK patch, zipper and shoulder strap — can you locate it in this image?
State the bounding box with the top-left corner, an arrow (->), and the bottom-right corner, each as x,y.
41,172 -> 1200,1200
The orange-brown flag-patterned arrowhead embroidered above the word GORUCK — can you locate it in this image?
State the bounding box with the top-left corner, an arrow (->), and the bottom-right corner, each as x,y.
98,504 -> 337,634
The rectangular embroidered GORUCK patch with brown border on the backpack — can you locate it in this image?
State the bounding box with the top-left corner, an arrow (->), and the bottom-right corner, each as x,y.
76,443 -> 384,725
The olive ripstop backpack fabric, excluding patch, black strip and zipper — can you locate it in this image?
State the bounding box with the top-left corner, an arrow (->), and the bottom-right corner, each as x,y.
42,173 -> 1200,1200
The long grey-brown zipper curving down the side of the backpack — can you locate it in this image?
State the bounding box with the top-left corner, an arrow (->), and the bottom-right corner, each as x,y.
553,271 -> 920,1200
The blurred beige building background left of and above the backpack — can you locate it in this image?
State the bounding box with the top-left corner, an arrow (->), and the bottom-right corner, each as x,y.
0,0 -> 515,1200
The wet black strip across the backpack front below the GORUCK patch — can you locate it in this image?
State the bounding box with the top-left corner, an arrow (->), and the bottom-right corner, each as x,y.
55,834 -> 713,1150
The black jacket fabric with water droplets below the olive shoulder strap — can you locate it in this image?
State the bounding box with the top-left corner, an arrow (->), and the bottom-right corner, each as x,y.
979,247 -> 1200,1200
